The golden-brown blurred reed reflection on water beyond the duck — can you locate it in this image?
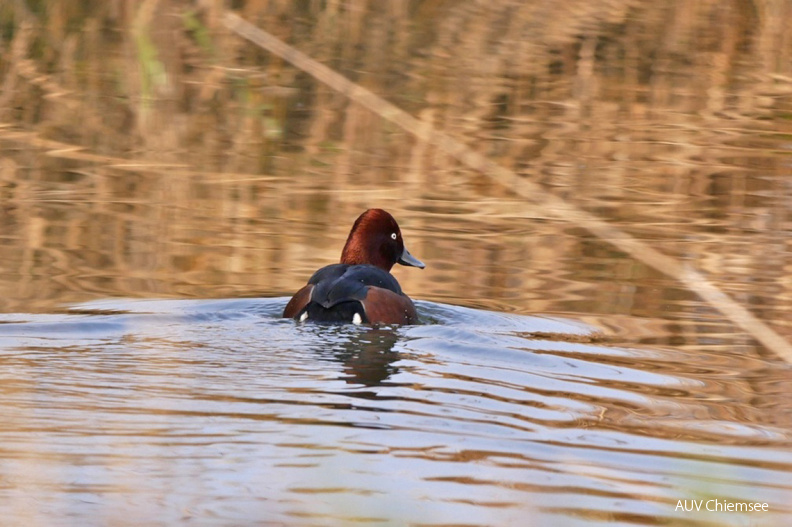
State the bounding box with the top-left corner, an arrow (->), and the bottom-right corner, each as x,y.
0,1 -> 792,356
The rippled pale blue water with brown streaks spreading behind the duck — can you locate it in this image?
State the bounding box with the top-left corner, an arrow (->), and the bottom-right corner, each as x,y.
0,298 -> 792,525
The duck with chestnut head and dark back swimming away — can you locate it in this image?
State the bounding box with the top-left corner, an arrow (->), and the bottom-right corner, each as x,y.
283,209 -> 426,325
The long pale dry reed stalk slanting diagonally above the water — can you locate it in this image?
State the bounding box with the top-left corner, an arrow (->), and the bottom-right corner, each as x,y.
224,13 -> 792,363
